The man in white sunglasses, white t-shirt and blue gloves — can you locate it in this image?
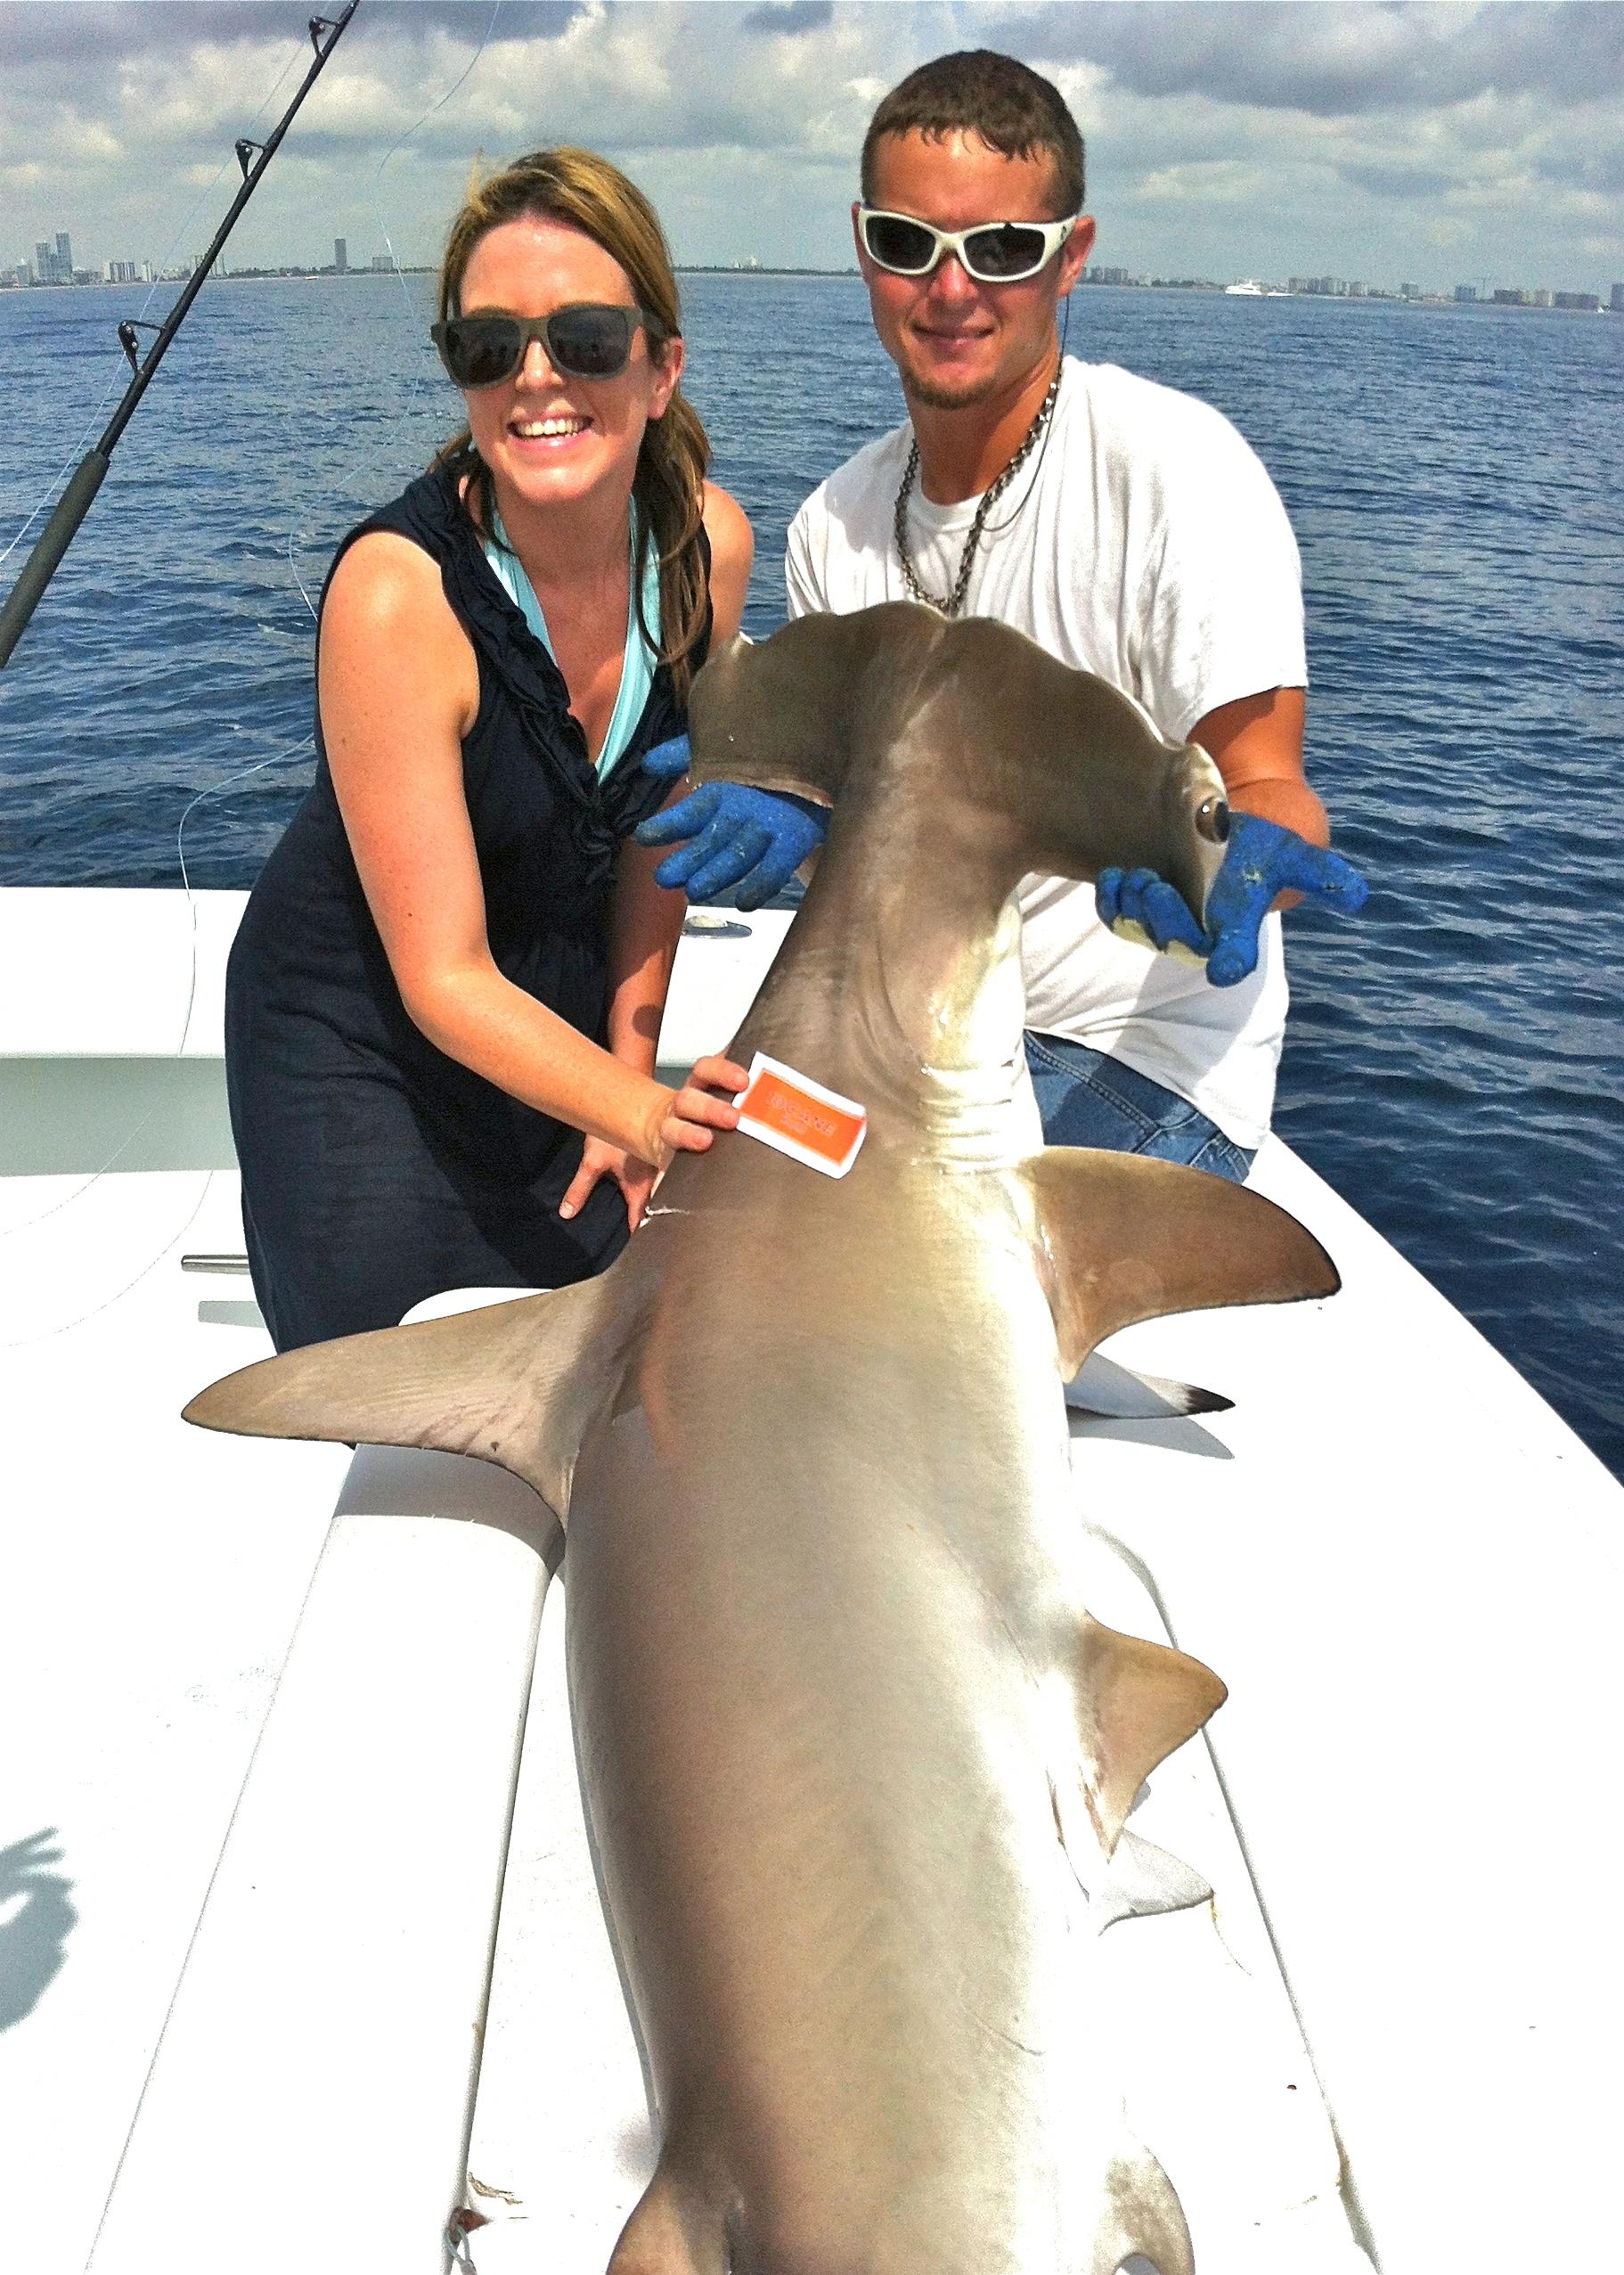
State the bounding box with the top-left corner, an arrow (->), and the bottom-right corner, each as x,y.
639,50 -> 1362,1178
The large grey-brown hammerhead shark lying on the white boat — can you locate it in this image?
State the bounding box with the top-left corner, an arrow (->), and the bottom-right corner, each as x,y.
186,603 -> 1337,2275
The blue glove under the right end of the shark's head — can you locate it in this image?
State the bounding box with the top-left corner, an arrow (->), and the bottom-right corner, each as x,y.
1094,807 -> 1369,987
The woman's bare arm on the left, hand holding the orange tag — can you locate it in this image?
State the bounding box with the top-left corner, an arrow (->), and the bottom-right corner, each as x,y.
318,532 -> 737,1165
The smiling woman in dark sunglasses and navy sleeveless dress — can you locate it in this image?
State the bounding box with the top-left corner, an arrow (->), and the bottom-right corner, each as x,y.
225,150 -> 751,1349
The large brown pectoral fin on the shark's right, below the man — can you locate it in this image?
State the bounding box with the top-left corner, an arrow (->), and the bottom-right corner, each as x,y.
1026,1147 -> 1342,1377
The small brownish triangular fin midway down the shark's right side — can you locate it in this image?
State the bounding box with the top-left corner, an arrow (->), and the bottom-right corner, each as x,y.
1076,1616 -> 1226,1856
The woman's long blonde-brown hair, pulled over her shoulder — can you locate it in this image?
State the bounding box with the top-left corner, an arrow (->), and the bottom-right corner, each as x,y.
435,148 -> 710,700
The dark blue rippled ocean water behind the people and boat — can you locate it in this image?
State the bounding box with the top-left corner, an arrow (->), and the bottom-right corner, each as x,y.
0,275 -> 1624,1477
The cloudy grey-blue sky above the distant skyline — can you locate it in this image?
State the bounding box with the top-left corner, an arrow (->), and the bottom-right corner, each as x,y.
0,0 -> 1624,298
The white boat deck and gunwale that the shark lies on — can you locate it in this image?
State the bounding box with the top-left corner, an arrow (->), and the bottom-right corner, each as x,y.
0,889 -> 1624,2275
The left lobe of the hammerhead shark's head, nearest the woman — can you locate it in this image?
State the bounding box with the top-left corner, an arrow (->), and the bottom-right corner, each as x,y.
690,601 -> 946,806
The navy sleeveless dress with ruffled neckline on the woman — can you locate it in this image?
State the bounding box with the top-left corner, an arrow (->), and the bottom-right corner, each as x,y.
225,471 -> 710,1351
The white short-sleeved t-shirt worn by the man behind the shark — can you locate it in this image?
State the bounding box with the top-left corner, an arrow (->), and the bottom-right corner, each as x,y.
785,357 -> 1308,1147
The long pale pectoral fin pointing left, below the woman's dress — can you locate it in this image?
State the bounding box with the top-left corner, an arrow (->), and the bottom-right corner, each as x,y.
184,1270 -> 641,1522
